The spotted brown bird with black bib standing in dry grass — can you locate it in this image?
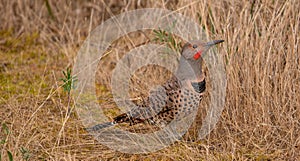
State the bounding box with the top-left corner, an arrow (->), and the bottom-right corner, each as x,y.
86,40 -> 224,132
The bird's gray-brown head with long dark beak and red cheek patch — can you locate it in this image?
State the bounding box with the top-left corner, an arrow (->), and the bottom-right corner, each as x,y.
182,40 -> 224,61
